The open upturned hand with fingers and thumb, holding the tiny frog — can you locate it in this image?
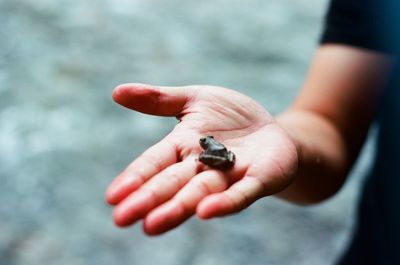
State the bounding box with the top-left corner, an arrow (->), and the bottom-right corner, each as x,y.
106,84 -> 298,235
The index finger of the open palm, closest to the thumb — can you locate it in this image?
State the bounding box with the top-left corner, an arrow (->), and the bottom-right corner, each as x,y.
106,139 -> 178,205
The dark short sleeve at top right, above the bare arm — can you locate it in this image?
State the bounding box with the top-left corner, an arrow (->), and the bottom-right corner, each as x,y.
321,0 -> 400,53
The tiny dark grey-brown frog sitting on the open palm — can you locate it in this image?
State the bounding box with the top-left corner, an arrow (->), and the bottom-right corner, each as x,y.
199,136 -> 235,169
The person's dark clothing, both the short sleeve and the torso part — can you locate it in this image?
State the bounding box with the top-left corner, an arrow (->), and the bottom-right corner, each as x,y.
321,0 -> 400,265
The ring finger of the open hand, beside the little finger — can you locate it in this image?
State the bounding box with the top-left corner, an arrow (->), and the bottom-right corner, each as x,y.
144,170 -> 228,235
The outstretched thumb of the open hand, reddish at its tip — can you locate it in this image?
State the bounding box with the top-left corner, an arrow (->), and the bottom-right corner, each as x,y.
112,84 -> 193,116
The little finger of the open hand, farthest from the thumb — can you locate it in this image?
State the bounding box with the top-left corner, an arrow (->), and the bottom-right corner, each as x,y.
196,176 -> 266,219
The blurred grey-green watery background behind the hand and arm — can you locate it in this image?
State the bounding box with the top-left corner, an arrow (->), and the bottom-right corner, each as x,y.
0,0 -> 374,265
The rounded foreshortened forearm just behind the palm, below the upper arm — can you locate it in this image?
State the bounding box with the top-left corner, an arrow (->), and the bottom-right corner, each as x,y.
277,109 -> 354,204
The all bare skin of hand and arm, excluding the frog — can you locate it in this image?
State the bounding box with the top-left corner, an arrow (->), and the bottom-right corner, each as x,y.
106,45 -> 393,235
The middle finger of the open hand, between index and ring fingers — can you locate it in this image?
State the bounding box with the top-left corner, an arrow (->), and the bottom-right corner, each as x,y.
114,157 -> 199,227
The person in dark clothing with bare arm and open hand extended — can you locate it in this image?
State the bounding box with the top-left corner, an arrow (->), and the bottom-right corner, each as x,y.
106,0 -> 400,264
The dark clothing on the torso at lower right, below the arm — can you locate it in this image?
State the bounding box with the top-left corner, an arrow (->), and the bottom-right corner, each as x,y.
339,65 -> 400,265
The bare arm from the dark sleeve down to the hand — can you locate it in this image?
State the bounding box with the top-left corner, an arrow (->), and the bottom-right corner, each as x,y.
277,45 -> 393,203
